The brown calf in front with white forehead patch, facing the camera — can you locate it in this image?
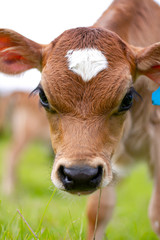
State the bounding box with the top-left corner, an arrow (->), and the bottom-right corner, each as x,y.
0,0 -> 160,239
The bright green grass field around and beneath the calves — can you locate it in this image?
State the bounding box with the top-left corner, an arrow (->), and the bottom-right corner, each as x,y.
0,135 -> 158,240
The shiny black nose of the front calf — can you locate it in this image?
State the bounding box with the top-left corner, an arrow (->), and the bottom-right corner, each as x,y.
58,166 -> 102,192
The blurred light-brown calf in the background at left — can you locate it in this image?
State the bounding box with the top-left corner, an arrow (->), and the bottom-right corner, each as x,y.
0,92 -> 49,195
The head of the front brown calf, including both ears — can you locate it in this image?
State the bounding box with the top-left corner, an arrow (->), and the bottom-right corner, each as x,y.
0,28 -> 160,194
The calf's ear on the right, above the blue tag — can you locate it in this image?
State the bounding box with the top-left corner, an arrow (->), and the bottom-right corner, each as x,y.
136,43 -> 160,85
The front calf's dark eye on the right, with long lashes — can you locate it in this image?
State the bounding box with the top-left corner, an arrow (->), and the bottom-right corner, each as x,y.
118,87 -> 142,112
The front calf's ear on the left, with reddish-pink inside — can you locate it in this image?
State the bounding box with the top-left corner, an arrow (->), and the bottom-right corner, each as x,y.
0,29 -> 42,74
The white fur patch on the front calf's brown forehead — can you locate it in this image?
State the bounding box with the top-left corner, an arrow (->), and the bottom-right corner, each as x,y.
66,48 -> 108,82
